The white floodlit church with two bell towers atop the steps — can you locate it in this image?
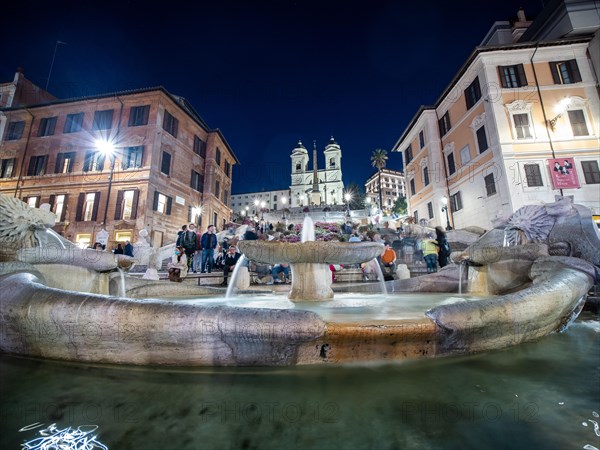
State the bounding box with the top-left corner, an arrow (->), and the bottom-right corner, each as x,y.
290,136 -> 344,207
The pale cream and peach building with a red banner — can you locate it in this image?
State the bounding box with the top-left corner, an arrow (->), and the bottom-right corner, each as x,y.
393,1 -> 600,229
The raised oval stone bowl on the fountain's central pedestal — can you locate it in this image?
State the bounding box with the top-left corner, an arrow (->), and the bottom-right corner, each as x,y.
238,241 -> 384,264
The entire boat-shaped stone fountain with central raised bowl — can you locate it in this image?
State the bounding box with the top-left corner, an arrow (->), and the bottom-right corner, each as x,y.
0,195 -> 600,366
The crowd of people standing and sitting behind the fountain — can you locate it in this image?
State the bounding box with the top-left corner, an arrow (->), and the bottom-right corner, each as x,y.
105,221 -> 451,286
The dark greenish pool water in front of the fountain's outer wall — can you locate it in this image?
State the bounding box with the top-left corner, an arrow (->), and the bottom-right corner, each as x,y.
0,316 -> 600,450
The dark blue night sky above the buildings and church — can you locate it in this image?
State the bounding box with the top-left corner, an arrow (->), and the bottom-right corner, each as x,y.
0,0 -> 543,193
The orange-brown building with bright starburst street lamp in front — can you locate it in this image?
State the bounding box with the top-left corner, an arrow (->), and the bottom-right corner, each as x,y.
0,75 -> 239,248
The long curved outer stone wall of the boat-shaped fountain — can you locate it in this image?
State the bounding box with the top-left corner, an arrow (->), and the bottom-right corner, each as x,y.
0,257 -> 595,366
